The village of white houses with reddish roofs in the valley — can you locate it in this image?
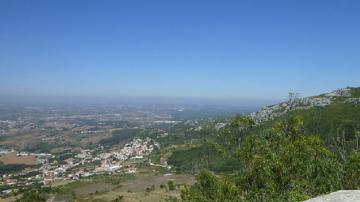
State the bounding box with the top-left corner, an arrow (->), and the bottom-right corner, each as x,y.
0,137 -> 163,196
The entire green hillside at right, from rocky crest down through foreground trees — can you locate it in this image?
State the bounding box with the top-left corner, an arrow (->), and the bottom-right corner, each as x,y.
180,88 -> 360,202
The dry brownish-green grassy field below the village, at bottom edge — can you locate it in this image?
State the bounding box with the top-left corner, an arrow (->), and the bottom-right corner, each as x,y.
49,174 -> 194,202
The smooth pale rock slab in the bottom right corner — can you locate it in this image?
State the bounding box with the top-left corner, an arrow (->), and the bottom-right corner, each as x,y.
305,190 -> 360,202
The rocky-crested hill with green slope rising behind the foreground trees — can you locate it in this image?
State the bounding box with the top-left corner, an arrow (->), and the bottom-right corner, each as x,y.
250,87 -> 360,160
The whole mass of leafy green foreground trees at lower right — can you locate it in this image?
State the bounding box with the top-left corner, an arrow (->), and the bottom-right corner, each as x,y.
181,116 -> 360,202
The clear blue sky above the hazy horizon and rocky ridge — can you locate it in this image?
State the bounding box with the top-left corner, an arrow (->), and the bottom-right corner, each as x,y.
0,0 -> 360,99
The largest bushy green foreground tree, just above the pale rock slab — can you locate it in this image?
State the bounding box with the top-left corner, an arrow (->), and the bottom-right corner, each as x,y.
237,117 -> 341,201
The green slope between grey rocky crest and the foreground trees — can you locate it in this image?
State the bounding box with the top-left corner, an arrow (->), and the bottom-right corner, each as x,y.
282,103 -> 360,161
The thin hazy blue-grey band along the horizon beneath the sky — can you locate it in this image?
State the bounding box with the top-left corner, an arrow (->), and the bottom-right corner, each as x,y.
0,95 -> 283,110
